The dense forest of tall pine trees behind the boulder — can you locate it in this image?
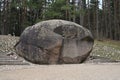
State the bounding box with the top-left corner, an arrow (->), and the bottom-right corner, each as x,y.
0,0 -> 120,40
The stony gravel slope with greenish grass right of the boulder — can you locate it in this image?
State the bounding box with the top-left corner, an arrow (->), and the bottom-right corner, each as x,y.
91,41 -> 120,61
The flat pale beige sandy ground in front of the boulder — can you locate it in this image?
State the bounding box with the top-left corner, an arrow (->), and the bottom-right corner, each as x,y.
0,64 -> 120,80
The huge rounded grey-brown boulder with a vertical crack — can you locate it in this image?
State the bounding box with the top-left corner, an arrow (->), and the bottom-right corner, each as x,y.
15,20 -> 94,64
